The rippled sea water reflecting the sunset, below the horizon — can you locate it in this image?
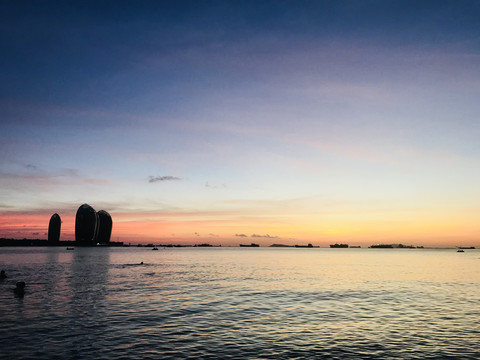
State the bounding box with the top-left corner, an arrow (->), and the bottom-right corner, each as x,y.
0,248 -> 480,359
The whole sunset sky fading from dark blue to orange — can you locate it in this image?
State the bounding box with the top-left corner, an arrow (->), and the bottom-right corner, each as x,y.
0,0 -> 480,246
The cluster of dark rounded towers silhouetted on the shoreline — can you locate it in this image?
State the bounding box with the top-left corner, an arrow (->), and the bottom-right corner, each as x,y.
48,204 -> 113,245
